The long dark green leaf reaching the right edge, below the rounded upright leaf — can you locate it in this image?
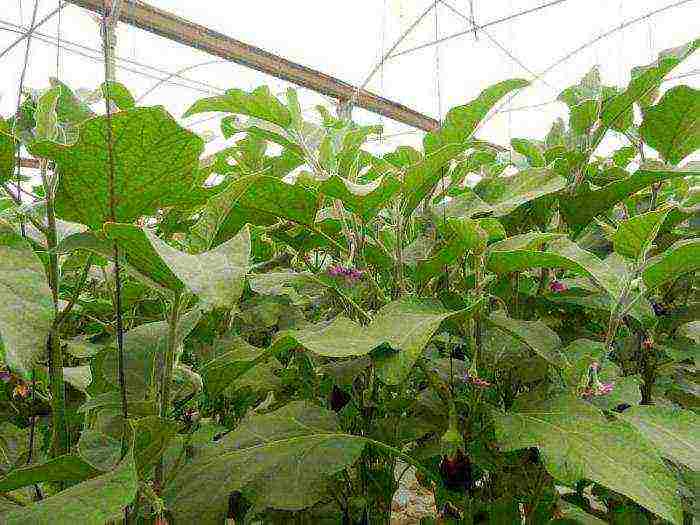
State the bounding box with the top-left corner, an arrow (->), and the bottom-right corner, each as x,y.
559,162 -> 700,234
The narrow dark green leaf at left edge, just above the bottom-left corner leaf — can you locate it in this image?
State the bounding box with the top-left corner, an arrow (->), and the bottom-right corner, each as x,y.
0,455 -> 101,492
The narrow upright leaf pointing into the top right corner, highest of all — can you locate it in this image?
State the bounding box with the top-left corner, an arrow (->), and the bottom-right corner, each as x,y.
595,39 -> 700,143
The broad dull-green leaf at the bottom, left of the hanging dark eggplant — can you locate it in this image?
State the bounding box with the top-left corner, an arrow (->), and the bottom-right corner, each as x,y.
164,401 -> 364,523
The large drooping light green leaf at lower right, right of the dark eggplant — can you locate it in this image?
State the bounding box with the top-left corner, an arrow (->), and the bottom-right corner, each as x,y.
496,395 -> 683,525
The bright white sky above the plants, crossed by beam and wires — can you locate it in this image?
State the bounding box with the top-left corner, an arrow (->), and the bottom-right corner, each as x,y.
0,0 -> 700,156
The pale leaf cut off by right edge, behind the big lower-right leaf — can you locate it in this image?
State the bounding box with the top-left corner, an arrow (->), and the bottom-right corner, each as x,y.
621,405 -> 700,471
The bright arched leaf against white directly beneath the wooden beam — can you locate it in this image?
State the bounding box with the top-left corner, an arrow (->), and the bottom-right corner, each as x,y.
183,86 -> 292,129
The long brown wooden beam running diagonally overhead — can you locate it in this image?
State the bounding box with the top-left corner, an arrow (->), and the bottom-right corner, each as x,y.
68,0 -> 439,131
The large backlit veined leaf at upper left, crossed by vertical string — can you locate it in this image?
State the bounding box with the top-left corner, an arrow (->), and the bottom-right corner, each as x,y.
30,107 -> 204,230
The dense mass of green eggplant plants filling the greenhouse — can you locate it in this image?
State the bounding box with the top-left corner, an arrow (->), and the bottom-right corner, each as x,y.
0,37 -> 700,525
